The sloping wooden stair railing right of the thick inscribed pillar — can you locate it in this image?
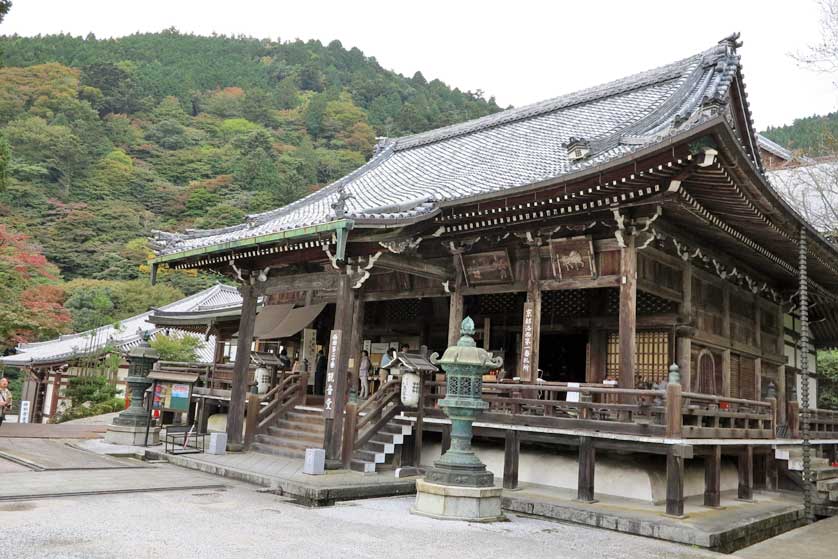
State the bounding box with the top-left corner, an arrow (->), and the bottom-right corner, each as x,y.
341,380 -> 402,466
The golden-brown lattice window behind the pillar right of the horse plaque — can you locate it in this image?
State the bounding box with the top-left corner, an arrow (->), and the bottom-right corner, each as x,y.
605,330 -> 669,387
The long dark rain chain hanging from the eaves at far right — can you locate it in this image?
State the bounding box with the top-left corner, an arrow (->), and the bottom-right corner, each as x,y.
798,227 -> 815,523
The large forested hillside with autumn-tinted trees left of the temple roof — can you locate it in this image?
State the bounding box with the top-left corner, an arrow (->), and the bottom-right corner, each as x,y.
0,30 -> 498,350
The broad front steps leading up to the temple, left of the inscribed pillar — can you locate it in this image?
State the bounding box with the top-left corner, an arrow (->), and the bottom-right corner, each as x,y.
250,407 -> 325,458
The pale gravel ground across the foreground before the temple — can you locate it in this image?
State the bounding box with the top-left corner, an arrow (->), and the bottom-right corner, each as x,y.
0,482 -> 722,559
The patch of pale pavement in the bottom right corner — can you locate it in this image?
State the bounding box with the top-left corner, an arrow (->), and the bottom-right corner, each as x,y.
735,516 -> 838,559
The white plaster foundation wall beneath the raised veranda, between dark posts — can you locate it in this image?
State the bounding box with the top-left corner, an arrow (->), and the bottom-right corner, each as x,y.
422,441 -> 739,504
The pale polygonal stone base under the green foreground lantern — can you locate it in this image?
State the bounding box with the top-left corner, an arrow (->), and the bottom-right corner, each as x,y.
410,479 -> 506,522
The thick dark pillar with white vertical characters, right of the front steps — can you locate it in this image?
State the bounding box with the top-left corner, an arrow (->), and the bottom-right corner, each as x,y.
323,273 -> 357,467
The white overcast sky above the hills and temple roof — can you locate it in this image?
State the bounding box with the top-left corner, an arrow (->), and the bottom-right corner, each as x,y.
0,0 -> 838,130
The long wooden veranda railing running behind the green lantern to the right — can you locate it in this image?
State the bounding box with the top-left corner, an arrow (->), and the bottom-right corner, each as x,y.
423,381 -> 780,439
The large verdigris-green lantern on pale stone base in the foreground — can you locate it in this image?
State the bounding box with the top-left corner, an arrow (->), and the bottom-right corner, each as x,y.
413,317 -> 503,522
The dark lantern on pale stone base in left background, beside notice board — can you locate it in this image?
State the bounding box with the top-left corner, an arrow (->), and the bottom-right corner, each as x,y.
105,333 -> 160,445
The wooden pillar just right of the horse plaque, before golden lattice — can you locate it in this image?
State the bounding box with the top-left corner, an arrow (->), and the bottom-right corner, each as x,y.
619,235 -> 640,388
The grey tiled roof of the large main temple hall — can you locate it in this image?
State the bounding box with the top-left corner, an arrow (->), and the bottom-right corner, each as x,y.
154,36 -> 739,256
